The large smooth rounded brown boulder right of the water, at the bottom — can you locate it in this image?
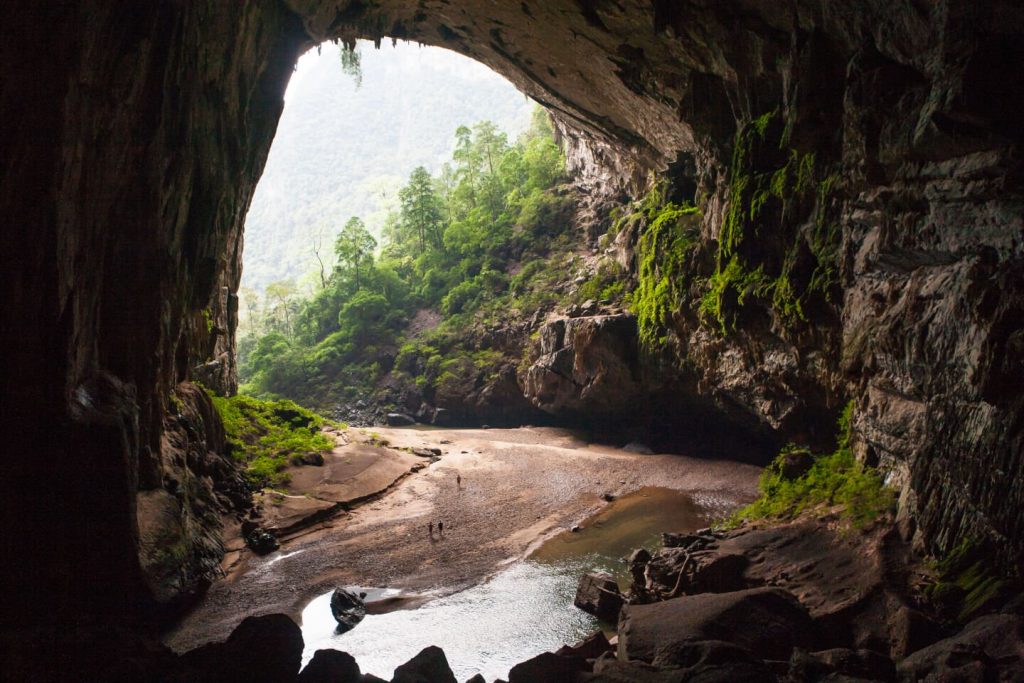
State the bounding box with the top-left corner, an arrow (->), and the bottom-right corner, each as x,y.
618,588 -> 813,666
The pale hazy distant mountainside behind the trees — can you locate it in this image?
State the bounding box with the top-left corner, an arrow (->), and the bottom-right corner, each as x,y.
243,43 -> 532,290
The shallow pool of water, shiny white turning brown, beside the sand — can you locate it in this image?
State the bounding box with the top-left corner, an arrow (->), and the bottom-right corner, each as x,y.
302,488 -> 707,681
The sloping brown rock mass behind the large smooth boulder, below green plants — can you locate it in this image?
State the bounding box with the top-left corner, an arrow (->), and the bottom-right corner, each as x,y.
630,520 -> 942,659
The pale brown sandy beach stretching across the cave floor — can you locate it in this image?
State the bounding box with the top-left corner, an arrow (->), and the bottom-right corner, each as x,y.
165,427 -> 760,651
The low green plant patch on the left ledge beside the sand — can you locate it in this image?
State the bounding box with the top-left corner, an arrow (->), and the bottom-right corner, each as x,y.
210,393 -> 335,488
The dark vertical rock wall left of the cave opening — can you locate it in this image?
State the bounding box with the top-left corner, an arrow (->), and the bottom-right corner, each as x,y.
0,1 -> 305,620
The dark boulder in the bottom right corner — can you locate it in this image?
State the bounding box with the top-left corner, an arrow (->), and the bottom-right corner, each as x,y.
897,614 -> 1024,683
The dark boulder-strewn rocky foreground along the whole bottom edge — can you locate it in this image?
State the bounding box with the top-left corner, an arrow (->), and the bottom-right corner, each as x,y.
37,516 -> 1024,683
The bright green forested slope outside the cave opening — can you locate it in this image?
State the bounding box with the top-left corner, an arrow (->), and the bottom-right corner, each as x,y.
239,108 -> 573,407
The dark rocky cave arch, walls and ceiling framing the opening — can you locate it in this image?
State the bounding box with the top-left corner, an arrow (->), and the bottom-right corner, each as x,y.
0,0 -> 1024,651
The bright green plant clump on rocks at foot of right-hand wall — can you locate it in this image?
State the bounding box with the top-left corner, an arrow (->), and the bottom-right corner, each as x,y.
726,401 -> 895,528
